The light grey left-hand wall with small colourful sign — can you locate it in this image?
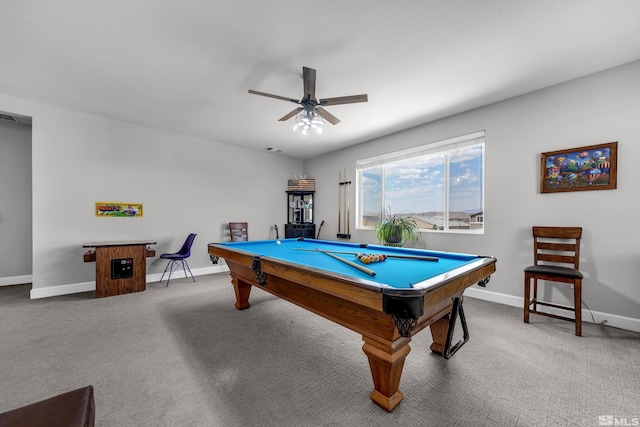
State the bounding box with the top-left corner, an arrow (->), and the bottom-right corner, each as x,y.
0,95 -> 302,296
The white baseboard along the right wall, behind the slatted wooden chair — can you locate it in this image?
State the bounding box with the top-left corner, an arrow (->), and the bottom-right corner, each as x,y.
465,287 -> 640,332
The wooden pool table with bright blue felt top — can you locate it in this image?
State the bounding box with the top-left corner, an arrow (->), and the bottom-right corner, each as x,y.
208,238 -> 496,412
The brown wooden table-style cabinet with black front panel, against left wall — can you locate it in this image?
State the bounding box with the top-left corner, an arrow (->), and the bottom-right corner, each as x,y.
82,240 -> 156,298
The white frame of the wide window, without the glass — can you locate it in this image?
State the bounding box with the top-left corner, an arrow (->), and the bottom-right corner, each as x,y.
356,130 -> 486,234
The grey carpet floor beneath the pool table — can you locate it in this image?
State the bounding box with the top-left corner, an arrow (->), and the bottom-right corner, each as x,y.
0,273 -> 640,427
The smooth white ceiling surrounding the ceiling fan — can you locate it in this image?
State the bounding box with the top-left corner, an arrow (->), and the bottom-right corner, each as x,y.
0,0 -> 640,158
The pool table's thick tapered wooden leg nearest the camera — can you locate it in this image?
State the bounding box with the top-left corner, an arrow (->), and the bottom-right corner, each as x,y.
362,336 -> 411,412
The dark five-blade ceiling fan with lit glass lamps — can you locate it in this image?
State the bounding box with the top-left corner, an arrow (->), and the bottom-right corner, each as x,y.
249,67 -> 368,134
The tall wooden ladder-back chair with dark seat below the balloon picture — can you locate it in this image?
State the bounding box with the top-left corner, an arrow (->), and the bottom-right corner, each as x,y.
524,227 -> 582,336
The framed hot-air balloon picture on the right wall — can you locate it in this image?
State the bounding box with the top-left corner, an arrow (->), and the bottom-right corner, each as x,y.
540,142 -> 618,193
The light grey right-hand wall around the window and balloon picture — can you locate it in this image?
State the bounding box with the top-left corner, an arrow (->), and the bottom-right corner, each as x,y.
305,62 -> 640,330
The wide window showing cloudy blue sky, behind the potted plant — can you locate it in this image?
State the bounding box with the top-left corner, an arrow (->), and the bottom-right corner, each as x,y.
356,131 -> 485,233
